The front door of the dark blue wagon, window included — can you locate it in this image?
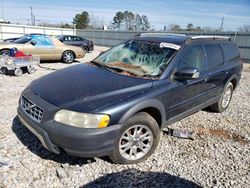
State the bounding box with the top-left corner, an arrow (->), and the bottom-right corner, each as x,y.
167,45 -> 207,119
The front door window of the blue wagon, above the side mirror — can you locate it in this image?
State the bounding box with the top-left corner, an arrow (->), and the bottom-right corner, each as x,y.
177,46 -> 205,72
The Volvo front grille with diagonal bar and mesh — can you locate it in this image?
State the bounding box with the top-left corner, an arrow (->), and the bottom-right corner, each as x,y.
21,96 -> 43,123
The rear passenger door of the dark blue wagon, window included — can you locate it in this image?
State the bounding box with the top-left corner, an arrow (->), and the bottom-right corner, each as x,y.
204,44 -> 228,99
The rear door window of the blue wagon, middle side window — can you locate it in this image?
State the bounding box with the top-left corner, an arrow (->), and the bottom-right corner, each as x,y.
205,44 -> 224,70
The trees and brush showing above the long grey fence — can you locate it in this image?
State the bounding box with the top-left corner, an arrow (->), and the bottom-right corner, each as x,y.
35,11 -> 250,32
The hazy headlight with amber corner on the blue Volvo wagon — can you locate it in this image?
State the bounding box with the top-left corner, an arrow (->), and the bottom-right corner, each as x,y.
54,109 -> 110,128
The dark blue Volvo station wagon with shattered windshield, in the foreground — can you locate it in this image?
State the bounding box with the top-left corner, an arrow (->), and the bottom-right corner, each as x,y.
18,35 -> 243,164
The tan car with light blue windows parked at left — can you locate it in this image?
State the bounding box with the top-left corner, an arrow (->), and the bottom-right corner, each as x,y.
0,34 -> 85,63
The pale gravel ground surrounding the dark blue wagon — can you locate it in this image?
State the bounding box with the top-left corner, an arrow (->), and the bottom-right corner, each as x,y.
0,47 -> 250,188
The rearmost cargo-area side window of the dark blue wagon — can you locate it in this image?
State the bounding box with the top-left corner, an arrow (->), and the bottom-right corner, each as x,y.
222,44 -> 240,63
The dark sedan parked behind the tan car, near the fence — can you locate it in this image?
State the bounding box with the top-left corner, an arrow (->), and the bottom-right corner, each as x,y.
56,35 -> 94,52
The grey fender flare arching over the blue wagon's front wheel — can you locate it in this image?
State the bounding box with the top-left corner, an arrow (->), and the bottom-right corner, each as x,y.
119,99 -> 166,126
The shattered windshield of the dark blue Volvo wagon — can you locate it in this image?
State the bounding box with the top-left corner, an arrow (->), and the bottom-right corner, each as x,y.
94,40 -> 176,77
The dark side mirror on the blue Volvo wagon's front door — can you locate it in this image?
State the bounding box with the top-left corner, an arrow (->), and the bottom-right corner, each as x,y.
174,68 -> 200,80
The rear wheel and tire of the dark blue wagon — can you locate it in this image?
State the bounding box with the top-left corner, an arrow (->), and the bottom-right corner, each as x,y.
210,82 -> 234,113
